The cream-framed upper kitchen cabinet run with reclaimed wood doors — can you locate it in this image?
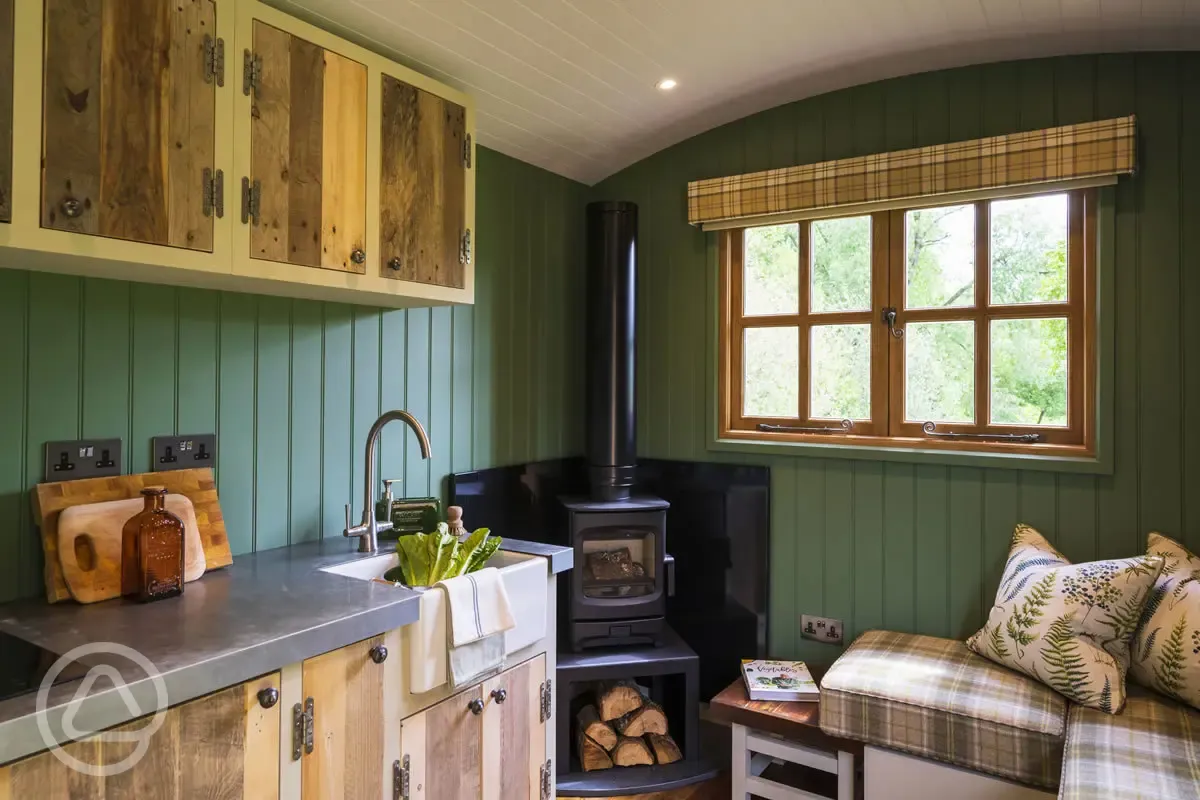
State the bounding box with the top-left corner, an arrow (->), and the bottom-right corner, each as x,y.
0,0 -> 475,307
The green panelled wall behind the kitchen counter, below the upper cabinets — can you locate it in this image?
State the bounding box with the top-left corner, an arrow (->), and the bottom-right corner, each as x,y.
0,149 -> 586,601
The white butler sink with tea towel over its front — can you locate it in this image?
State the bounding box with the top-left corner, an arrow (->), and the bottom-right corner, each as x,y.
323,547 -> 550,694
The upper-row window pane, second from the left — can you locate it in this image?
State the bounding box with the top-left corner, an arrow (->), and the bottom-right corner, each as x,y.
809,217 -> 871,313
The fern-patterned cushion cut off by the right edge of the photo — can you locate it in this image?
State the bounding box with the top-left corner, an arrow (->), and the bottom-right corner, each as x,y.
1129,534 -> 1200,709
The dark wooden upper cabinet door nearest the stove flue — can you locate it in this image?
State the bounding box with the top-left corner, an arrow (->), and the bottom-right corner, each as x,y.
379,74 -> 469,289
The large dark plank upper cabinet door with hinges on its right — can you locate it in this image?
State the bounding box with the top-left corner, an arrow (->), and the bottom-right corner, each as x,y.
42,0 -> 223,252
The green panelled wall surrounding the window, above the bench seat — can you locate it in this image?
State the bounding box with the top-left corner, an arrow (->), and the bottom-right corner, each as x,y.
593,53 -> 1200,662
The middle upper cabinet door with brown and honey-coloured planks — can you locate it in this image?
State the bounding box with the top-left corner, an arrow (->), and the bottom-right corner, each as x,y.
250,19 -> 367,273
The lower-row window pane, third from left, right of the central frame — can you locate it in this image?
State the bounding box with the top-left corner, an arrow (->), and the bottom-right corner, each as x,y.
904,320 -> 974,422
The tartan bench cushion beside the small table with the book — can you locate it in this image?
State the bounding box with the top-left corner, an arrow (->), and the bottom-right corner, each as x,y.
821,631 -> 1067,789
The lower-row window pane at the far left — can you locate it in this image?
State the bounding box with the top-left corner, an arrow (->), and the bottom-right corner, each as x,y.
742,327 -> 800,417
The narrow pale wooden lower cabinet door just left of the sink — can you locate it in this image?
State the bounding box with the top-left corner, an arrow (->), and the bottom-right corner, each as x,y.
300,636 -> 384,800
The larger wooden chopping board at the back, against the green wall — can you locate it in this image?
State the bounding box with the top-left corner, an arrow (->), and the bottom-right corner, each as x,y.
30,468 -> 233,603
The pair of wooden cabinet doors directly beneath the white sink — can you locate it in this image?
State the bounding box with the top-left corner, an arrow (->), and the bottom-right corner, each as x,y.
400,655 -> 546,800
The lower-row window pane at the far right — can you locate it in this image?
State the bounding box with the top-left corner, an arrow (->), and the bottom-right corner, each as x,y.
990,318 -> 1067,427
